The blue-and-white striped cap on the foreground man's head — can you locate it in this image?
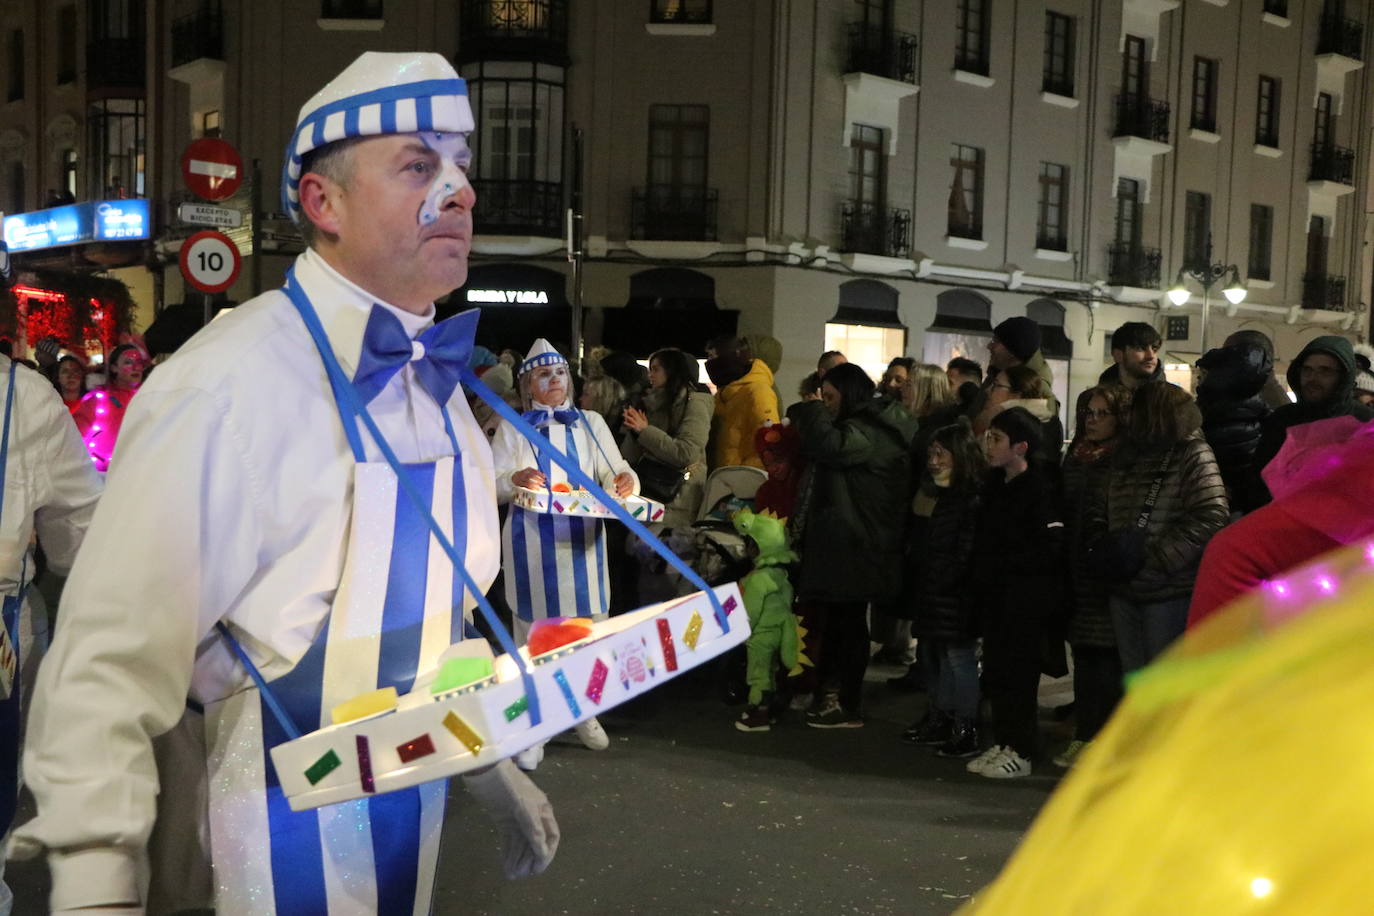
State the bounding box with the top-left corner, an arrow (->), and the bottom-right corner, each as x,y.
282,51 -> 474,224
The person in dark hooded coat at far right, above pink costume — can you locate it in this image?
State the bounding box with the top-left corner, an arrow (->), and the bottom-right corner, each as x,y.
1254,335 -> 1374,504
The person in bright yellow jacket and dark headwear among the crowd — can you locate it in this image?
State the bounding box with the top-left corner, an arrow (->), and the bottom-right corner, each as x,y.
706,338 -> 780,470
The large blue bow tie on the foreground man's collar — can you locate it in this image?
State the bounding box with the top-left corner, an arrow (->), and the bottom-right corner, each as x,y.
353,305 -> 481,407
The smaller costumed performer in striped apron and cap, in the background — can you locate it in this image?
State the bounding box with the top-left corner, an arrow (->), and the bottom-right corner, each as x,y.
492,338 -> 639,770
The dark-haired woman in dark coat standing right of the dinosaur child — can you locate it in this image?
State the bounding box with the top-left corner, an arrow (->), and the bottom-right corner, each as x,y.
793,363 -> 916,728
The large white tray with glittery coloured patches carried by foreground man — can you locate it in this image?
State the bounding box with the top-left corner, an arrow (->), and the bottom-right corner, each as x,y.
272,584 -> 749,810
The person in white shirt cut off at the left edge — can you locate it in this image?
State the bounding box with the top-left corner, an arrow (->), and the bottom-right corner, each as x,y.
0,354 -> 100,916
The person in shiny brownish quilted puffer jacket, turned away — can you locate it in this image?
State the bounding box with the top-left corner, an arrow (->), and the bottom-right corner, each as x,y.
1085,380 -> 1230,673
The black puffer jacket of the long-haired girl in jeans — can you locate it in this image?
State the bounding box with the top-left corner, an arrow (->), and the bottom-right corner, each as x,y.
901,478 -> 978,640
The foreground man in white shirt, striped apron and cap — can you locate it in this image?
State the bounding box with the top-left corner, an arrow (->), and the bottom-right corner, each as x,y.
16,52 -> 558,916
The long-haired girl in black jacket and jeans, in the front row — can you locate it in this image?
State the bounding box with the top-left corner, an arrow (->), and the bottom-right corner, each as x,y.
901,423 -> 988,757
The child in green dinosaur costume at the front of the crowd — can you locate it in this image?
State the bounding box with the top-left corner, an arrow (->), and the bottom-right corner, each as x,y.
734,509 -> 809,732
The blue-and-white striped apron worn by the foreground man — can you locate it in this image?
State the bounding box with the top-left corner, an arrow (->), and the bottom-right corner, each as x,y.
206,283 -> 475,916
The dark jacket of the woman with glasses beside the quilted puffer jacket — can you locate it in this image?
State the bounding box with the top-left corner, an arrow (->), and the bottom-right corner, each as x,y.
1061,439 -> 1116,648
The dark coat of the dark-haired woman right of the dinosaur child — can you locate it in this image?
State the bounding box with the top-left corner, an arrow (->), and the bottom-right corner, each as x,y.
793,398 -> 916,602
